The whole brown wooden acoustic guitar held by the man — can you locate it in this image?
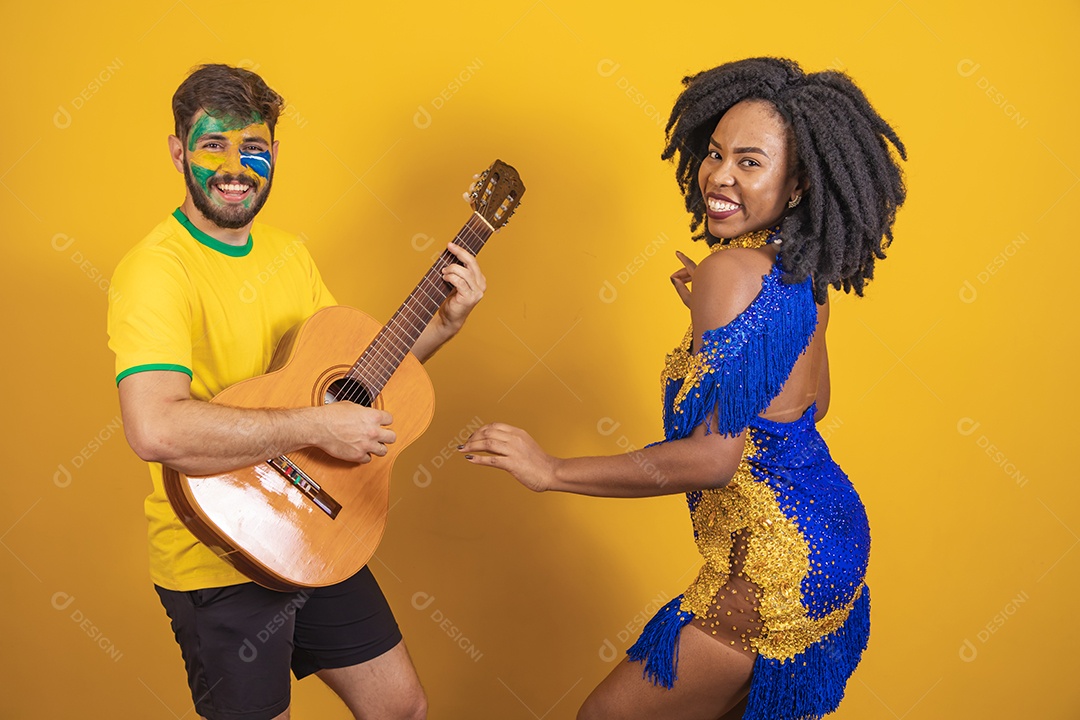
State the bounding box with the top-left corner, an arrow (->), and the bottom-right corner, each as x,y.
164,160 -> 525,590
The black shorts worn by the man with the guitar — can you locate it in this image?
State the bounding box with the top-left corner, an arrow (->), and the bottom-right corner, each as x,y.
154,567 -> 402,720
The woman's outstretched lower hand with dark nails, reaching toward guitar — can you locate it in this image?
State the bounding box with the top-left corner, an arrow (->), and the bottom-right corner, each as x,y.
458,422 -> 561,492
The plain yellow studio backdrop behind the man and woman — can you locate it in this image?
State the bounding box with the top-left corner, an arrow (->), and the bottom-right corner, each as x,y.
0,0 -> 1080,720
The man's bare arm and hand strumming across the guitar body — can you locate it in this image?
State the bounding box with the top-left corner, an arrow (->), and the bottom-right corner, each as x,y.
119,370 -> 395,475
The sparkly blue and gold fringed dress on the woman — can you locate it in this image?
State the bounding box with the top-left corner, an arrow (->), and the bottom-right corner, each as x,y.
626,259 -> 869,720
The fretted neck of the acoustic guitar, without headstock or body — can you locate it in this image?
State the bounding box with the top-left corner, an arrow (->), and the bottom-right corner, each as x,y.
348,213 -> 494,398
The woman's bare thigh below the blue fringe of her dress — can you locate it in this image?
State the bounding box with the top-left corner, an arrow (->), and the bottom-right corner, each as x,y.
578,625 -> 754,720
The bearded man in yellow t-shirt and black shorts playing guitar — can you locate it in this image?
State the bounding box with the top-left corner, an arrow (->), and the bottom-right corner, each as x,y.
109,65 -> 485,720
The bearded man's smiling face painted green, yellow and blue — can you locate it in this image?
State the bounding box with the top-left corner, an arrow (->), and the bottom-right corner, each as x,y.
185,110 -> 273,228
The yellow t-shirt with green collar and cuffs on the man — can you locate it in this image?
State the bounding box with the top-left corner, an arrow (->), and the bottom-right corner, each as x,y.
109,208 -> 335,590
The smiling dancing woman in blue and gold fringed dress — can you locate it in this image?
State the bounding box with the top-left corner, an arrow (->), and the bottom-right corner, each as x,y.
461,58 -> 905,719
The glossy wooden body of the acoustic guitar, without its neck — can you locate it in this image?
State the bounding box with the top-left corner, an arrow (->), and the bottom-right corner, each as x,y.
164,305 -> 434,590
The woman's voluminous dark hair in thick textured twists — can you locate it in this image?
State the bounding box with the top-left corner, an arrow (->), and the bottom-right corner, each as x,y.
661,57 -> 907,302
